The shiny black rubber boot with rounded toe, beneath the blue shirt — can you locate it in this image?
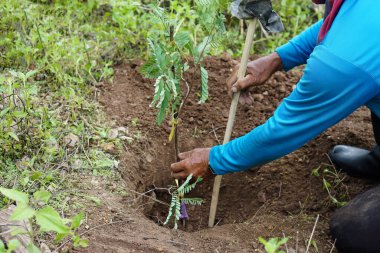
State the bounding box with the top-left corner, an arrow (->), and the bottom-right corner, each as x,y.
329,113 -> 380,180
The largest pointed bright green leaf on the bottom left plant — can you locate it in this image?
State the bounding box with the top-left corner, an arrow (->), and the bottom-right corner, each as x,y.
36,206 -> 70,234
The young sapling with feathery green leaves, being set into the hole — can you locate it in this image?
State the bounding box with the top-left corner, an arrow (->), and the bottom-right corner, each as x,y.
140,0 -> 225,228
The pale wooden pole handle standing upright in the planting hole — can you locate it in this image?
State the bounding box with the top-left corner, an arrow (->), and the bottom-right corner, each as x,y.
208,19 -> 256,227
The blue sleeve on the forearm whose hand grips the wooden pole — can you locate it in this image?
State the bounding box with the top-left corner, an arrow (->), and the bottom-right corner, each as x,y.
276,20 -> 323,71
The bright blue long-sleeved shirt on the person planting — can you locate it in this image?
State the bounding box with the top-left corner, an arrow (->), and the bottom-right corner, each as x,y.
210,0 -> 380,175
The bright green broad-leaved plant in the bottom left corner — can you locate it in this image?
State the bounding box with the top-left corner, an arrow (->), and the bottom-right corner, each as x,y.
0,187 -> 88,253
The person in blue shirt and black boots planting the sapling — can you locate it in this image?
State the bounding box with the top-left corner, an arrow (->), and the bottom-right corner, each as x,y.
172,0 -> 380,253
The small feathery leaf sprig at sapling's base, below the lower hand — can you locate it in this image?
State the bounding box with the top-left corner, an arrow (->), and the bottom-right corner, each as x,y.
164,174 -> 203,229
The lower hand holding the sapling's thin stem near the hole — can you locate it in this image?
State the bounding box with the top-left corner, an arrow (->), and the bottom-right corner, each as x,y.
171,148 -> 212,179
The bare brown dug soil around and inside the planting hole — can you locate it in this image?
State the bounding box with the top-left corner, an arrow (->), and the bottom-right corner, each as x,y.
82,57 -> 374,252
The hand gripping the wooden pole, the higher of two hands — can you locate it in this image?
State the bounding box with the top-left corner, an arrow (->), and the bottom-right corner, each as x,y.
227,53 -> 282,105
